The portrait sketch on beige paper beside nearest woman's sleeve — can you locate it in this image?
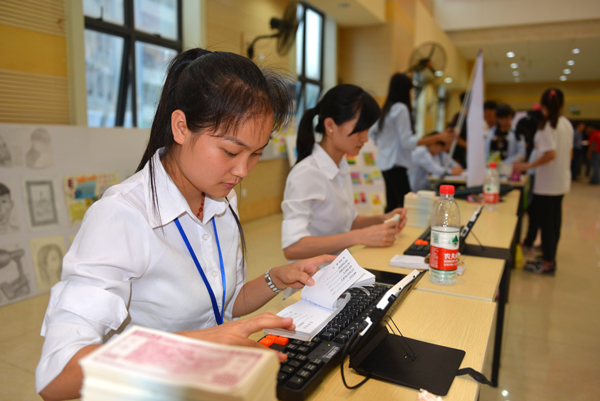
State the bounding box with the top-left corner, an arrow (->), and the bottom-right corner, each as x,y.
29,235 -> 66,292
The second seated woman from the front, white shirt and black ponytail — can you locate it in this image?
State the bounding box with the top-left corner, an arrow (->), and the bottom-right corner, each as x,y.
281,85 -> 406,260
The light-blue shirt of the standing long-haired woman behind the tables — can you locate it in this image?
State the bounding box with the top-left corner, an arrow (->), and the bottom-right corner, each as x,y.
369,103 -> 419,171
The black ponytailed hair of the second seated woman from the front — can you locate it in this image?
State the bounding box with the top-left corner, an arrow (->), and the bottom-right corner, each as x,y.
296,84 -> 381,163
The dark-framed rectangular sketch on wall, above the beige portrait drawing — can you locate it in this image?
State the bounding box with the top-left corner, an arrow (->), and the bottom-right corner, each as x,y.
25,180 -> 58,229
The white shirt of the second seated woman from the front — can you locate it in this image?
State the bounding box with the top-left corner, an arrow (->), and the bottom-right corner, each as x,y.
281,144 -> 358,252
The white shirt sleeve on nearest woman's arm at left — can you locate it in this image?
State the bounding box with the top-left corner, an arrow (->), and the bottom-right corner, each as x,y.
36,200 -> 151,392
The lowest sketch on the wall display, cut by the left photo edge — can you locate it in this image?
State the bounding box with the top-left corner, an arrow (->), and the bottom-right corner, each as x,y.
0,245 -> 34,305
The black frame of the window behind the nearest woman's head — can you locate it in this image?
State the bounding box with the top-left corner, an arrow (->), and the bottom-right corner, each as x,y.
84,0 -> 183,127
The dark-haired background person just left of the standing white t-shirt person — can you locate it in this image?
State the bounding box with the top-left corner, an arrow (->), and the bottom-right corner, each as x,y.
485,104 -> 525,166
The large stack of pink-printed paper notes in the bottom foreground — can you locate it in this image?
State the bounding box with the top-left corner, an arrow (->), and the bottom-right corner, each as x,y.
79,326 -> 279,401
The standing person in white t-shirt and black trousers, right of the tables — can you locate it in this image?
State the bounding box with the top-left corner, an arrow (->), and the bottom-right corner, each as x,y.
513,88 -> 573,274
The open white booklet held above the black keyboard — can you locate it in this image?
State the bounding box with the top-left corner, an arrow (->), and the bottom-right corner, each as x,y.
265,249 -> 375,341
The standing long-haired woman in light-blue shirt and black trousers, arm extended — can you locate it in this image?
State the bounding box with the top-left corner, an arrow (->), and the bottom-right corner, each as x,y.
369,73 -> 454,213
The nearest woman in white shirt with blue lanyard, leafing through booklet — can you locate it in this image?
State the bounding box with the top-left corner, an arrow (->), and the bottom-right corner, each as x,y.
36,49 -> 334,400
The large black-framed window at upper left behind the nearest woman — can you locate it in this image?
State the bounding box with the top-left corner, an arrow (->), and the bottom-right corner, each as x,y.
83,0 -> 182,128
